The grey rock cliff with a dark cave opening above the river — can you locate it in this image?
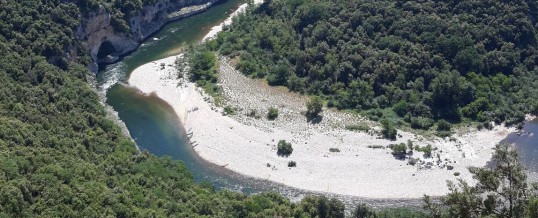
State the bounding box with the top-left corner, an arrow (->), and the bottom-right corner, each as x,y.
77,0 -> 219,68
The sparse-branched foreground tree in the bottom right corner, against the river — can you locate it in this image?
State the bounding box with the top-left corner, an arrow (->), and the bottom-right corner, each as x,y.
425,144 -> 536,217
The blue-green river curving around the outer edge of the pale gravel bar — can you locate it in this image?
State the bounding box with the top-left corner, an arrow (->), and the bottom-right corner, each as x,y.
97,0 -> 538,209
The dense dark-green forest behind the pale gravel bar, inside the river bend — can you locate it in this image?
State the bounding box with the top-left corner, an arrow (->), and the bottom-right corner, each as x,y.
211,0 -> 538,130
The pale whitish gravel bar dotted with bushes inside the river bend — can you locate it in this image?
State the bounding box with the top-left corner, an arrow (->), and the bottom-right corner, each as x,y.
129,52 -> 515,198
